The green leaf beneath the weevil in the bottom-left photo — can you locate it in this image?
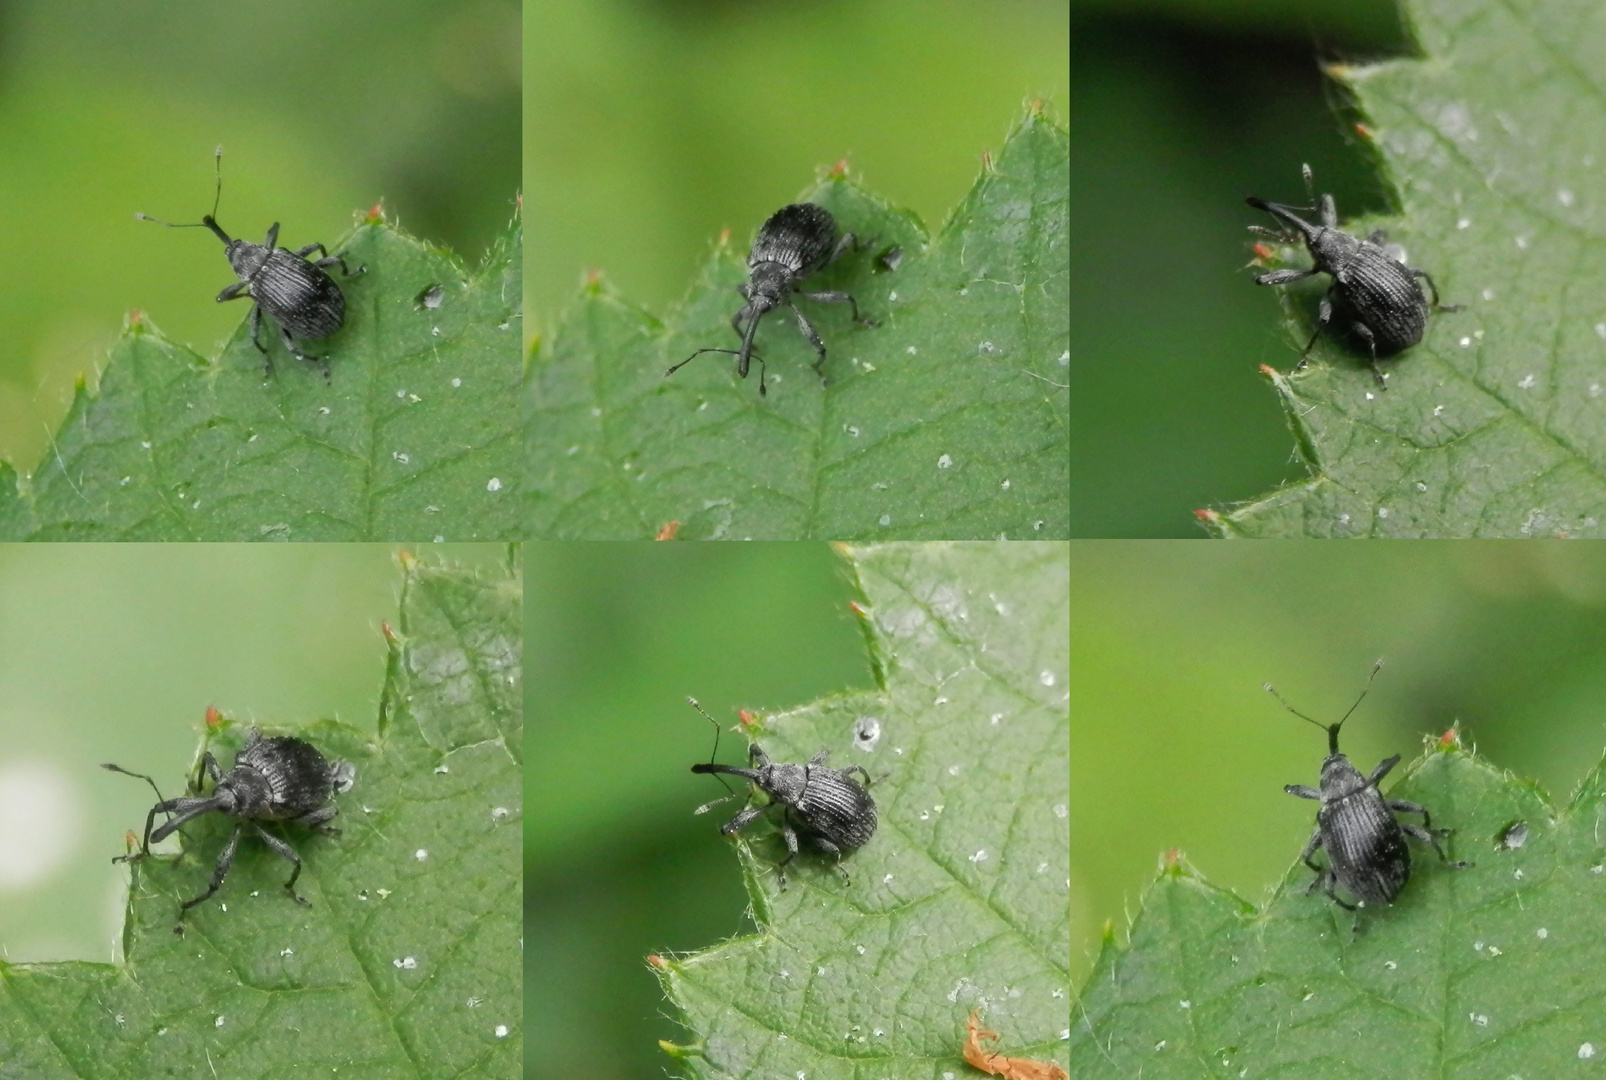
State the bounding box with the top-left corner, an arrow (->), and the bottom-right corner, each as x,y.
0,556 -> 524,1080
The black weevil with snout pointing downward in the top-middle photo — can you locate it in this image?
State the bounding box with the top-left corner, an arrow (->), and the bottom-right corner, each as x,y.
663,203 -> 896,397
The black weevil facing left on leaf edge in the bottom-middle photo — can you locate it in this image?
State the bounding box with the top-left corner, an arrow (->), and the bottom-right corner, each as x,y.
686,698 -> 877,889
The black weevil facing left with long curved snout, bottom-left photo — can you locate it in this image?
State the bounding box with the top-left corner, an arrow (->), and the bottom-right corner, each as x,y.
101,728 -> 355,934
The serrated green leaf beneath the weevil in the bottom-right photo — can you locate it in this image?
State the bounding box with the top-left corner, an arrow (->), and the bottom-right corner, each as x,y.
1071,747 -> 1606,1080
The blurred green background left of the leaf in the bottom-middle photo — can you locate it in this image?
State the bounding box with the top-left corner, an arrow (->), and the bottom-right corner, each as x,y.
524,543 -> 874,1080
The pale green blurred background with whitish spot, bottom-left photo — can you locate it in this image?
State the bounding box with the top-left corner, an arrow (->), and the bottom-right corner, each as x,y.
0,543 -> 506,963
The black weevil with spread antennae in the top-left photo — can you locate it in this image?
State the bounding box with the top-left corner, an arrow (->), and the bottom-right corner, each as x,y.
135,146 -> 368,381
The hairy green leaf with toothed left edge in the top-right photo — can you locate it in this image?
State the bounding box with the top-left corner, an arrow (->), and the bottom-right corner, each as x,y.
1206,0 -> 1606,537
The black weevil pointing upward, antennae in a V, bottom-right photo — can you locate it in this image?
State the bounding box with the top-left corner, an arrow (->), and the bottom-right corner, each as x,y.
1266,661 -> 1471,911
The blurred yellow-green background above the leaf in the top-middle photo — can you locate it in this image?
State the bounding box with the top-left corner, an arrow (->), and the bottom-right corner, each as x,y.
524,0 -> 1070,348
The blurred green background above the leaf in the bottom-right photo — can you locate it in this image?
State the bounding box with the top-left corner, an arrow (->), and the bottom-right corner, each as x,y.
1071,540 -> 1606,985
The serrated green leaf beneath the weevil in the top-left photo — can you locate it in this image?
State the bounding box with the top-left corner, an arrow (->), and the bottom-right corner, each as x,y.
0,219 -> 522,540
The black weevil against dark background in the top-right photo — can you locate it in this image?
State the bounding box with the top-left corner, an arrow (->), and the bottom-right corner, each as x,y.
1246,166 -> 1461,389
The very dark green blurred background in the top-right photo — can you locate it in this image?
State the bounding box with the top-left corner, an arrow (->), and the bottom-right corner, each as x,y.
1070,0 -> 1412,537
